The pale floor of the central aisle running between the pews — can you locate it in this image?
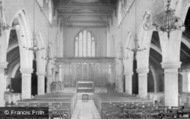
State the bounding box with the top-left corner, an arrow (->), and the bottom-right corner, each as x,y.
71,100 -> 101,119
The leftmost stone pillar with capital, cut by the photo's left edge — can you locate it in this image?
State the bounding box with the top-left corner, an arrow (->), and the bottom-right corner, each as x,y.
0,62 -> 7,107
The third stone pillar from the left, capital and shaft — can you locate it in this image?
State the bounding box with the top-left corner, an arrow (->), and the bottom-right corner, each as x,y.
37,72 -> 45,95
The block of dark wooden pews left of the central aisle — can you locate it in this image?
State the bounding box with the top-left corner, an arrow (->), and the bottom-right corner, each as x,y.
7,93 -> 76,119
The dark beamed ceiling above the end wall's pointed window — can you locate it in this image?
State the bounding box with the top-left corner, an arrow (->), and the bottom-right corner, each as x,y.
54,0 -> 117,27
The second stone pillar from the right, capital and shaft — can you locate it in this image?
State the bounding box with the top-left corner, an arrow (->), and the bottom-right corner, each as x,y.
137,69 -> 149,98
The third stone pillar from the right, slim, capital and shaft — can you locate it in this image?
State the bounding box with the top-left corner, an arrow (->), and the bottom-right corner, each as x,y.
125,72 -> 133,95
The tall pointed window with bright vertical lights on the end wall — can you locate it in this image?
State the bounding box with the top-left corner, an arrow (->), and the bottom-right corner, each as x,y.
75,30 -> 95,57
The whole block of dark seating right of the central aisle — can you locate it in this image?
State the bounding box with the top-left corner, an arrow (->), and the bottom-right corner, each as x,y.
94,94 -> 190,119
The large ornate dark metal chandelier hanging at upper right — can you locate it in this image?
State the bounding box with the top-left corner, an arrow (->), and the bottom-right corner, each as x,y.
143,0 -> 185,39
